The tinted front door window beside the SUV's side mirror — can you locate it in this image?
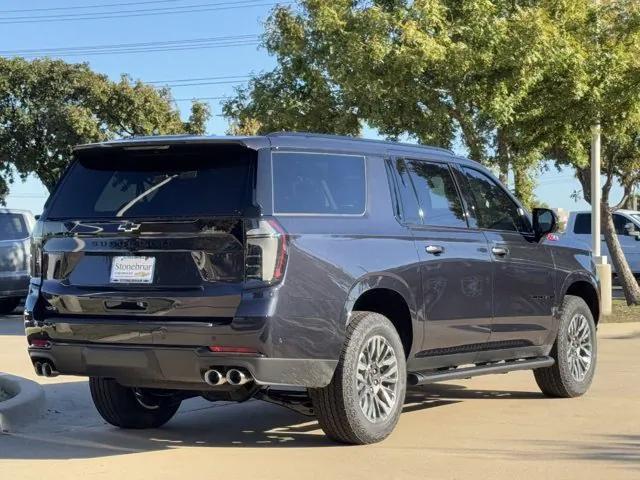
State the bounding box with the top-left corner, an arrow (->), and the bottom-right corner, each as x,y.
463,167 -> 532,233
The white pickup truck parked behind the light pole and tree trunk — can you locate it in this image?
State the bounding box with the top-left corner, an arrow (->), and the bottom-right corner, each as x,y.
563,210 -> 640,279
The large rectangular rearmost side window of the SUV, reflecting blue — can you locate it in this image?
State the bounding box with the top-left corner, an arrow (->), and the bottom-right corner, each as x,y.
272,152 -> 366,215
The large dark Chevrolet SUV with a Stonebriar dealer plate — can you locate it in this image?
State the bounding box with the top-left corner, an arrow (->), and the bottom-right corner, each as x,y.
25,133 -> 599,443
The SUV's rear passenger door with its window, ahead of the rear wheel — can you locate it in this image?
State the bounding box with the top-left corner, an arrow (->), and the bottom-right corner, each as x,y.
393,158 -> 492,366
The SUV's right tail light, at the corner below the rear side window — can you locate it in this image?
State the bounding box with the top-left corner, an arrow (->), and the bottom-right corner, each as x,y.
245,219 -> 288,285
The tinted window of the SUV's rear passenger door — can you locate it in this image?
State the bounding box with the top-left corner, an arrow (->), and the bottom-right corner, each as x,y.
407,160 -> 467,228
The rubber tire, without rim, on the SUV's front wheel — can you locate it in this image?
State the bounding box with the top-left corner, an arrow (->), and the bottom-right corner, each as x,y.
533,295 -> 598,398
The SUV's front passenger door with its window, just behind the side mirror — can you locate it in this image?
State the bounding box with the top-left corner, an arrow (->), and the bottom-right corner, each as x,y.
461,167 -> 555,350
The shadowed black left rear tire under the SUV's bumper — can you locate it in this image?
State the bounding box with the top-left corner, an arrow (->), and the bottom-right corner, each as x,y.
89,377 -> 181,429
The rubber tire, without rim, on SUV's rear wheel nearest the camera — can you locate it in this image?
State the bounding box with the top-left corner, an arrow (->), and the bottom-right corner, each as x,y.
309,312 -> 407,445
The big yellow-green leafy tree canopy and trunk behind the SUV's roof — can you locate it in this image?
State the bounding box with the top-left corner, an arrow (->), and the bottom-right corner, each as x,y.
224,0 -> 640,303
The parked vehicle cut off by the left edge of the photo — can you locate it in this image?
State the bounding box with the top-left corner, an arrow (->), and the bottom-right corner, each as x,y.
0,208 -> 35,315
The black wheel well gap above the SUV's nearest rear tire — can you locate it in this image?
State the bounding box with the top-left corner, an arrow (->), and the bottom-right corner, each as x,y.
353,288 -> 413,357
